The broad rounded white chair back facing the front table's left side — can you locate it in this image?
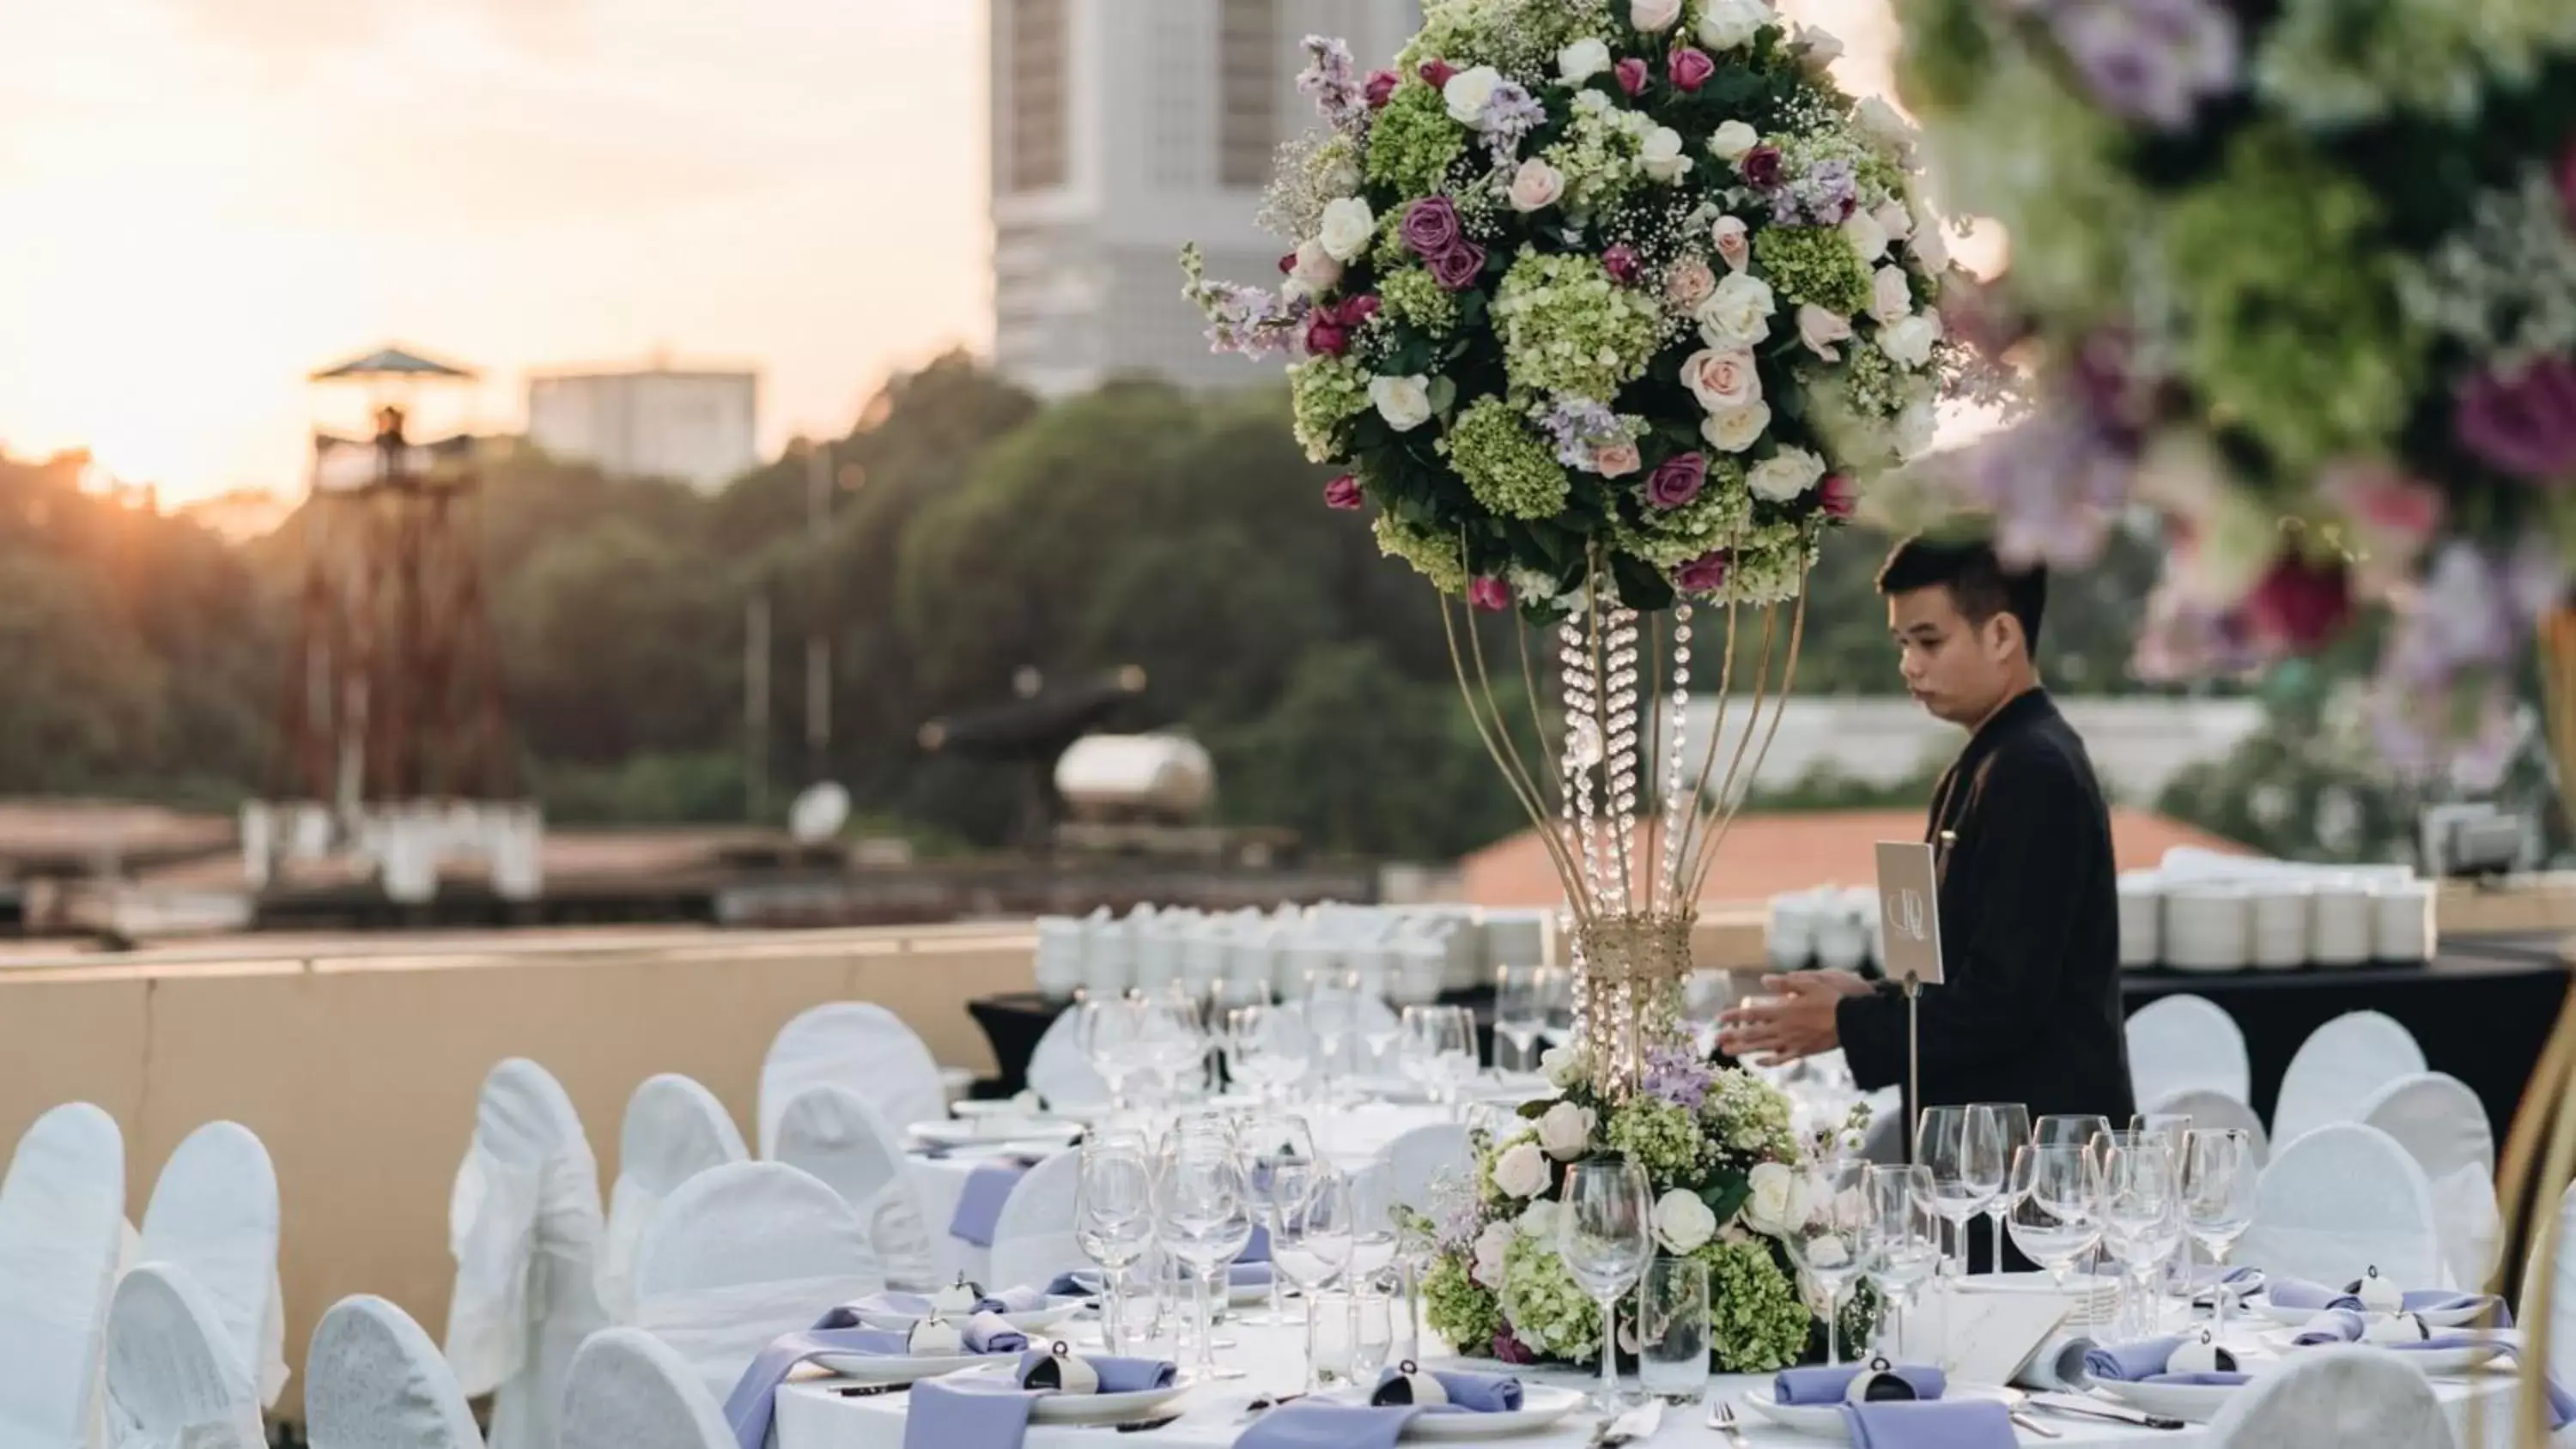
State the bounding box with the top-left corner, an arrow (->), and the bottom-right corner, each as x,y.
634,1163 -> 886,1403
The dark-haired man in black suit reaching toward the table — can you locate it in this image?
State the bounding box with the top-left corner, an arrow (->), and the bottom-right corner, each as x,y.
1721,538 -> 2136,1168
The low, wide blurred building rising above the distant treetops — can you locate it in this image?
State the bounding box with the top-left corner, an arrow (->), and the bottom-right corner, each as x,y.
528,363 -> 760,492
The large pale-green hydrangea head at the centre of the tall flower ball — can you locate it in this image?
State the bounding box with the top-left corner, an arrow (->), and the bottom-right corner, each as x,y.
1494,247 -> 1669,399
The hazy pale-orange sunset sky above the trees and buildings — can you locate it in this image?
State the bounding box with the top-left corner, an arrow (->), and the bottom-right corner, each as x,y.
0,0 -> 1927,502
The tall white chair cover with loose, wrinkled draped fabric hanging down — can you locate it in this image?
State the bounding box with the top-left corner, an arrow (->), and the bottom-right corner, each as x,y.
448,1058 -> 608,1449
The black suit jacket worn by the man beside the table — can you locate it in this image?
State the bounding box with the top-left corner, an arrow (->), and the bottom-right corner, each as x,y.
1834,690 -> 2136,1137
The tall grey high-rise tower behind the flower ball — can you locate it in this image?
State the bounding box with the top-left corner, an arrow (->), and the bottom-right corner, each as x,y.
989,0 -> 1422,394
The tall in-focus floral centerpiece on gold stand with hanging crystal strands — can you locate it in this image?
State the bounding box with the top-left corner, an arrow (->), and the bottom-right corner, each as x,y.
1182,0 -> 1971,1369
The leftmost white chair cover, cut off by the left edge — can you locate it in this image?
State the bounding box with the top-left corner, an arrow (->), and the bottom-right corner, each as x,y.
0,1101 -> 126,1449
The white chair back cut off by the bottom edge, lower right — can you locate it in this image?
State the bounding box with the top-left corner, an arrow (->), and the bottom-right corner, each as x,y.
2210,1349 -> 2442,1449
